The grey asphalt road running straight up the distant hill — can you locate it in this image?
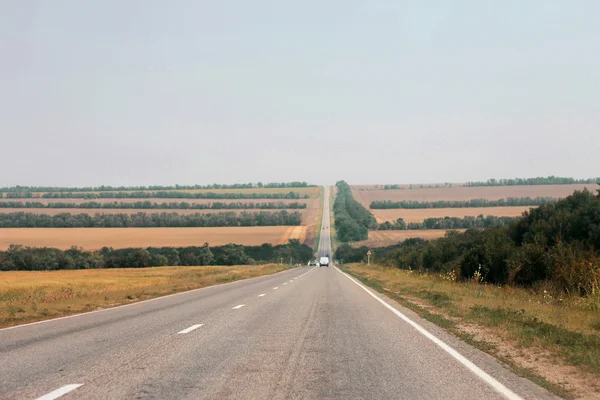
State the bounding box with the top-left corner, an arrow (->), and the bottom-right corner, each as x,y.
0,186 -> 552,399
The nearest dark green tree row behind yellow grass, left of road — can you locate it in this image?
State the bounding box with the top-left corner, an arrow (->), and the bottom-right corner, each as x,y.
0,239 -> 313,271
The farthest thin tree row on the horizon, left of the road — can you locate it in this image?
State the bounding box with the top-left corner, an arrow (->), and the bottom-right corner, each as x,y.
0,182 -> 316,193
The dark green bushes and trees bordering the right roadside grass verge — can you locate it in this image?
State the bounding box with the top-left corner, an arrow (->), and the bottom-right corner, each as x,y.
335,190 -> 600,296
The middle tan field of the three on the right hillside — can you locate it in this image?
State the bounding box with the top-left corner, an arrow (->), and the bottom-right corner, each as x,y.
371,206 -> 535,223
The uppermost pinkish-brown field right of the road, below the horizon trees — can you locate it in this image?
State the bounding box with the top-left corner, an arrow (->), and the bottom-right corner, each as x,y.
352,184 -> 598,208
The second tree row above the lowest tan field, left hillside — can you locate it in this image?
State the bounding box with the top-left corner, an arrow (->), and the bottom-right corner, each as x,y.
0,201 -> 307,210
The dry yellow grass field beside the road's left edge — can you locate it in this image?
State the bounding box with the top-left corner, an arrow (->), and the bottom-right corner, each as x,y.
0,264 -> 288,327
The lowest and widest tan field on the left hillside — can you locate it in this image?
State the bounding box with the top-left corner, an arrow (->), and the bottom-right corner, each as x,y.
0,226 -> 306,250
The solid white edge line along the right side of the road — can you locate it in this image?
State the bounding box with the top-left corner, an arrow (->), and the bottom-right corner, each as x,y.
335,267 -> 522,400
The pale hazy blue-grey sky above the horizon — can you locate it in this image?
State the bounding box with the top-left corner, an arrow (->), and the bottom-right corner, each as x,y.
0,0 -> 600,186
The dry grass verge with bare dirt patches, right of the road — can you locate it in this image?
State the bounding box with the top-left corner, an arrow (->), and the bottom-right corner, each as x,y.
343,264 -> 600,398
